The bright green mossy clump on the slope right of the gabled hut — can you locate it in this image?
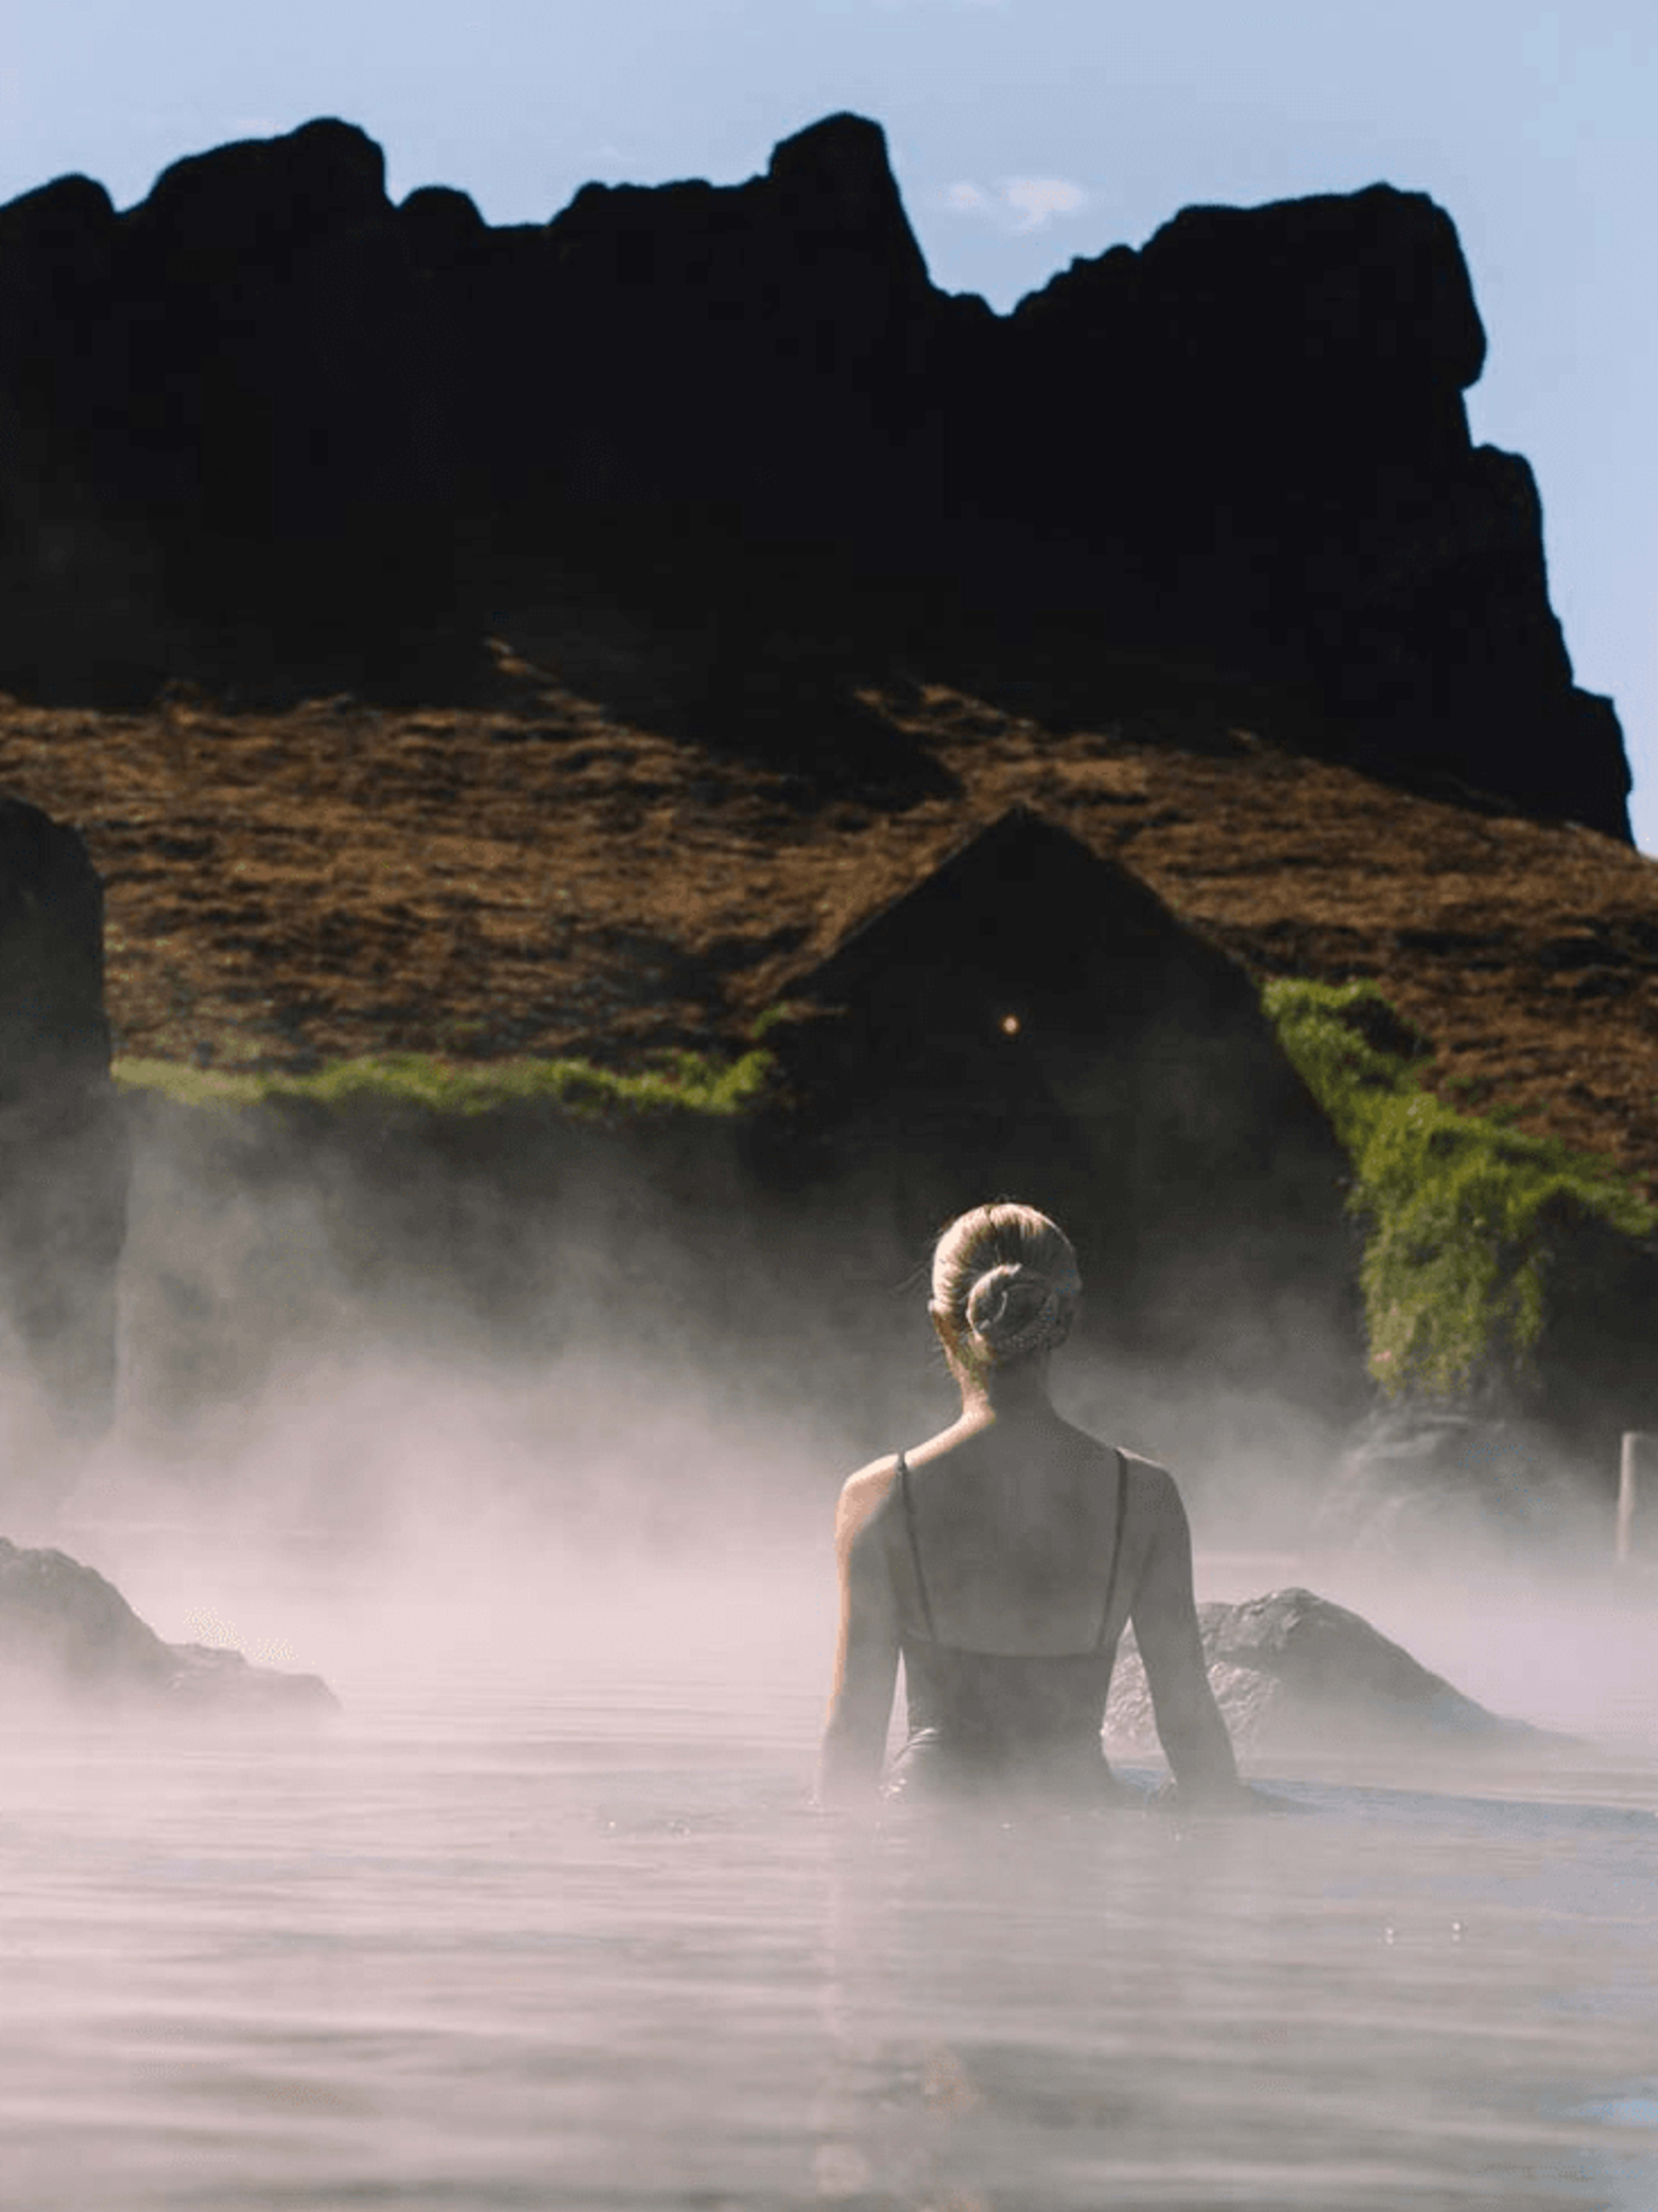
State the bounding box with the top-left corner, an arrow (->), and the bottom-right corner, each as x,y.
1262,980 -> 1658,1396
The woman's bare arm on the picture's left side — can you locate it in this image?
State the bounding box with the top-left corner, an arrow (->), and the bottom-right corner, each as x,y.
818,1460 -> 900,1807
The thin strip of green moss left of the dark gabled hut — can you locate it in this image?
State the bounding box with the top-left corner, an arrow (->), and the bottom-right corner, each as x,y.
115,1051 -> 774,1122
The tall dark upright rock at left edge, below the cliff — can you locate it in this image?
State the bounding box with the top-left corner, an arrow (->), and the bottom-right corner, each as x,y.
0,799 -> 128,1438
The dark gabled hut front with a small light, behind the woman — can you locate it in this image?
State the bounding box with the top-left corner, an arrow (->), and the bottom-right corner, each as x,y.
767,810 -> 1368,1418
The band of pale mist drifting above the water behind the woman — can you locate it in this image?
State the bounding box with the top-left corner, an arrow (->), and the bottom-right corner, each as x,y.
9,1097 -> 1654,1787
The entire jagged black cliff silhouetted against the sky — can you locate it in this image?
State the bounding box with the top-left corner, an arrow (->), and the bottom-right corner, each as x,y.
0,115 -> 1627,836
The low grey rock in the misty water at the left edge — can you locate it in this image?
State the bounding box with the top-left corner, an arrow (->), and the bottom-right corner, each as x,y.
0,1537 -> 338,1719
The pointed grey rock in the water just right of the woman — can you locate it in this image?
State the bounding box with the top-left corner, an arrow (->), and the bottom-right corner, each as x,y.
1105,1591 -> 1559,1752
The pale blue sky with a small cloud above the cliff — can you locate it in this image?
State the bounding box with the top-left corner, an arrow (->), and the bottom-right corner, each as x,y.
0,0 -> 1658,854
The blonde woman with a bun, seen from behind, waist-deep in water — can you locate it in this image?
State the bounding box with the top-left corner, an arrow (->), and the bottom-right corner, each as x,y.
823,1203 -> 1245,1805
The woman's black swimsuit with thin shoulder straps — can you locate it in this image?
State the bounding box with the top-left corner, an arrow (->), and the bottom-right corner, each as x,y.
889,1451 -> 1127,1796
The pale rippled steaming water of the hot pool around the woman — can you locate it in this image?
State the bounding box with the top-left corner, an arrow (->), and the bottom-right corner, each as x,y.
0,1404 -> 1658,2212
